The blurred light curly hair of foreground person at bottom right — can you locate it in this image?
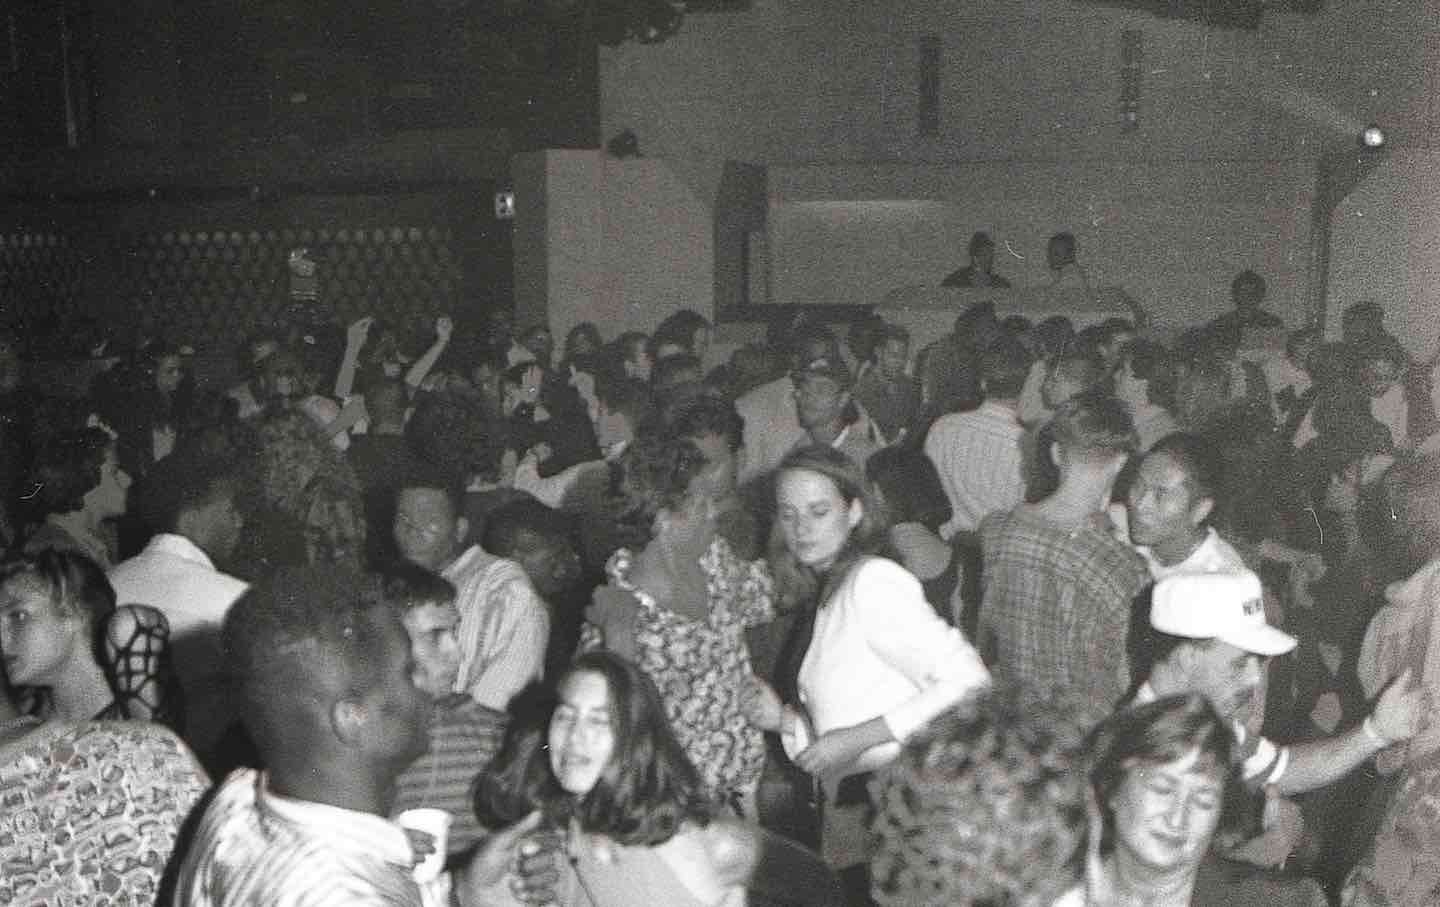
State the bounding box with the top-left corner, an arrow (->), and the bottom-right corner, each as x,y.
870,688 -> 1089,907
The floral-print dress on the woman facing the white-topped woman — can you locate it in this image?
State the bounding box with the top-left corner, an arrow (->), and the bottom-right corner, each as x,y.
580,538 -> 775,799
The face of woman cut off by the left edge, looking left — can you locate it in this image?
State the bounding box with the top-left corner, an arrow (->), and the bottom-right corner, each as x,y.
0,574 -> 86,687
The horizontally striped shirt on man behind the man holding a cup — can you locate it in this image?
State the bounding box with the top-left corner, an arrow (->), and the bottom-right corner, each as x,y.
390,694 -> 510,854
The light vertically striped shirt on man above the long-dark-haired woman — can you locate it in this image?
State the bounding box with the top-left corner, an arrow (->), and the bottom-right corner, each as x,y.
441,544 -> 550,711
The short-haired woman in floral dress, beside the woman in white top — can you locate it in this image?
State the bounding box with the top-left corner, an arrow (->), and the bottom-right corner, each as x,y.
580,435 -> 773,816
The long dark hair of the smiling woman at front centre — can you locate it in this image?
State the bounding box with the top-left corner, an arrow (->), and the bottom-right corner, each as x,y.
475,649 -> 711,847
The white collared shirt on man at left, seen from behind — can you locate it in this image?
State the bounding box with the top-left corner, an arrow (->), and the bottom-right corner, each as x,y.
109,533 -> 249,753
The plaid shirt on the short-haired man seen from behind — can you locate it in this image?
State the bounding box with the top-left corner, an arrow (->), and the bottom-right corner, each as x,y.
978,505 -> 1151,708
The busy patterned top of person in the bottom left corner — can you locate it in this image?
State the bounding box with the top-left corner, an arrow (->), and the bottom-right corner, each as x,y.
0,721 -> 210,907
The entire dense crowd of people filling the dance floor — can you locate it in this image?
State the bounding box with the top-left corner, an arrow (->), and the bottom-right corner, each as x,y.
0,272 -> 1440,907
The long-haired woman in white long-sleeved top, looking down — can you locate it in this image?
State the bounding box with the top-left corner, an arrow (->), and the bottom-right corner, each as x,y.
750,446 -> 989,892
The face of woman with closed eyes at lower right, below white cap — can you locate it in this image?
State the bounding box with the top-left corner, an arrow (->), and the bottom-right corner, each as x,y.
1110,750 -> 1224,871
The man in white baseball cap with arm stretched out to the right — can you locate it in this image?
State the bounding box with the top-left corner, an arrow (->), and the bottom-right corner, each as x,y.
1133,570 -> 1427,795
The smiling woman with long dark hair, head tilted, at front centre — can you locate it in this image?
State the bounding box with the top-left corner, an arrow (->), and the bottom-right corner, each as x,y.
456,652 -> 834,907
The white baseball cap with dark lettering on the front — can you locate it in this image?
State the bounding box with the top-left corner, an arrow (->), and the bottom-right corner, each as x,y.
1151,570 -> 1297,655
